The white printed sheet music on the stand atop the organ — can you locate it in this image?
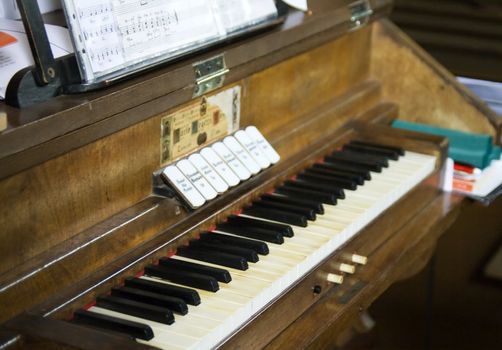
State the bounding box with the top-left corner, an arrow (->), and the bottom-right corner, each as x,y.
64,0 -> 277,82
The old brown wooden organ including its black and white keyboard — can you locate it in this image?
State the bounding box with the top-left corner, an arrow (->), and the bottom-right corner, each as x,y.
0,0 -> 501,349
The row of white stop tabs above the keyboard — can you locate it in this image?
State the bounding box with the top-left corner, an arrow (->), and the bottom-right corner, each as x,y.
161,126 -> 280,209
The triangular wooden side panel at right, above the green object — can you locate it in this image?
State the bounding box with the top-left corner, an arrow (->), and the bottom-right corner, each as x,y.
371,20 -> 502,142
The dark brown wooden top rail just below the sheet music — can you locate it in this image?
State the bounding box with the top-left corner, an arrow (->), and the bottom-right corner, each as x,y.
0,0 -> 390,178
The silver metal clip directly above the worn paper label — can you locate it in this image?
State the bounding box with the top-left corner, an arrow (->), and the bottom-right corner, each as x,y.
193,54 -> 230,98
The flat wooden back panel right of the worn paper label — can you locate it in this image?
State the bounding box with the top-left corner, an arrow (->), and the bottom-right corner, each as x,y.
243,27 -> 371,134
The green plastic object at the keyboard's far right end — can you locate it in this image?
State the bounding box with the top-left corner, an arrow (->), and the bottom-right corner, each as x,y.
392,119 -> 501,169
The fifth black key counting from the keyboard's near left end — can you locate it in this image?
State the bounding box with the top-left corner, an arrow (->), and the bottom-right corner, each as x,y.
145,265 -> 220,292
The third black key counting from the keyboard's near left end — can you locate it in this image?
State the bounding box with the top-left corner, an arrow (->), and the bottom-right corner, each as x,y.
112,287 -> 188,315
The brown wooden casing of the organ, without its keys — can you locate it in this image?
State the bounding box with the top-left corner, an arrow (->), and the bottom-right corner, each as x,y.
0,0 -> 502,349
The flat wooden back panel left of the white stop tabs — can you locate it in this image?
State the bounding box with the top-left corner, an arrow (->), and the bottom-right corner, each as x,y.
0,119 -> 159,272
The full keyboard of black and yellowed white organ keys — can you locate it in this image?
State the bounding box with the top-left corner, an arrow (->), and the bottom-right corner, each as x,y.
76,143 -> 436,349
